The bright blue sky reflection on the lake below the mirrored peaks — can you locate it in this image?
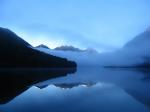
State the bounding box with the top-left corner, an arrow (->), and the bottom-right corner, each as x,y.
2,83 -> 147,112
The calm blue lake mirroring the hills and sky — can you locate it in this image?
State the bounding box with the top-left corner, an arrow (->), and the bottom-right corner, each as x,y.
0,67 -> 150,112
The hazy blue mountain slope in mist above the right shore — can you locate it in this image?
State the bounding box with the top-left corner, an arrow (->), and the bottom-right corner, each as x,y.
98,29 -> 150,67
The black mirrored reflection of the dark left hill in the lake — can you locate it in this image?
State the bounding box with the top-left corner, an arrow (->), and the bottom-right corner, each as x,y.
0,69 -> 75,103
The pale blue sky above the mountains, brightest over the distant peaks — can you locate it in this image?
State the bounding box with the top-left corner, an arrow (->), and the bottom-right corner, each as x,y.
0,0 -> 150,51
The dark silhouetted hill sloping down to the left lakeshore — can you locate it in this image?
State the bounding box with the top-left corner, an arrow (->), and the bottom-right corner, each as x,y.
0,28 -> 76,68
